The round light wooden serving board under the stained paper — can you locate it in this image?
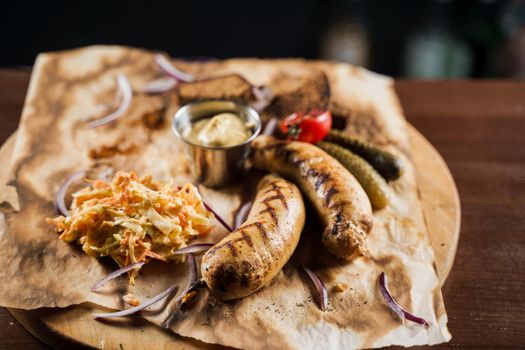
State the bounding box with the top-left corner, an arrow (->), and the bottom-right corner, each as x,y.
4,126 -> 461,349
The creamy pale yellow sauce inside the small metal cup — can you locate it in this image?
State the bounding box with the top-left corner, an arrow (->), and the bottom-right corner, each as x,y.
184,113 -> 253,147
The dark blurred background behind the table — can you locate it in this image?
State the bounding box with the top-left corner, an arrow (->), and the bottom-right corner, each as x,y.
0,0 -> 525,79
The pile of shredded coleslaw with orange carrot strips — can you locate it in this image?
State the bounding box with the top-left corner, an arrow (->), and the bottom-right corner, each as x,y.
47,171 -> 214,281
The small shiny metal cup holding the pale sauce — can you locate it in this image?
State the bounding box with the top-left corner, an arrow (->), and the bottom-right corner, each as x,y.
172,101 -> 261,188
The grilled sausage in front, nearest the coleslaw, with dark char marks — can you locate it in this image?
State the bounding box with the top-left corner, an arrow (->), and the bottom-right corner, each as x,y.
201,175 -> 305,300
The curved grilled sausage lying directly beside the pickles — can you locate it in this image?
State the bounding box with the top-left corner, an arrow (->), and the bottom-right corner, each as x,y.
252,136 -> 373,260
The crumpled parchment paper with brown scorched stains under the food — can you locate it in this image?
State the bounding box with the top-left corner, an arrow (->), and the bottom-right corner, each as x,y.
0,46 -> 450,349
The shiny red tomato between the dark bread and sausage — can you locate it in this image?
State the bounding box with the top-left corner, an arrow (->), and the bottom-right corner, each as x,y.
281,109 -> 332,143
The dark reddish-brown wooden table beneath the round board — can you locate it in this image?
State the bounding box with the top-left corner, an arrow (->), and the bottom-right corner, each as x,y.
0,69 -> 525,349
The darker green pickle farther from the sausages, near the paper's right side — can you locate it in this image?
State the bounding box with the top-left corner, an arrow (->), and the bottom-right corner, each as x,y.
324,130 -> 405,181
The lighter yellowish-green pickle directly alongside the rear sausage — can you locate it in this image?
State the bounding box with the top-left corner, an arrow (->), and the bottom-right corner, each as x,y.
317,141 -> 389,209
